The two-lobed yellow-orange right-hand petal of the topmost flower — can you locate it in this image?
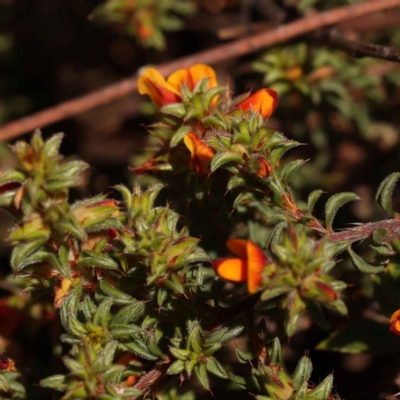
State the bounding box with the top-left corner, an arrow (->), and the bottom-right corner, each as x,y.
167,64 -> 218,90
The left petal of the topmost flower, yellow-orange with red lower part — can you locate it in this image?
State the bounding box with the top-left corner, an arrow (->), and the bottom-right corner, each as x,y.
138,68 -> 181,107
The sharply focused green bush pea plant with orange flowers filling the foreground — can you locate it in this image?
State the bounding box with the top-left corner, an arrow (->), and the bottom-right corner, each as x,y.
0,64 -> 400,400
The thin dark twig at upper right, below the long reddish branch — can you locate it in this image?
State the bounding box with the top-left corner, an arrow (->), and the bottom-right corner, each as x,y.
314,29 -> 400,62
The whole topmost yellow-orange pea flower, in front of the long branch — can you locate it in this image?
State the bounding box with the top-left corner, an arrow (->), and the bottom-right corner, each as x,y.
138,64 -> 218,107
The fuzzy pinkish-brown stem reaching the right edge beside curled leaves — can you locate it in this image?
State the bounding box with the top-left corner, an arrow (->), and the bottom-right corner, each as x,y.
327,219 -> 400,243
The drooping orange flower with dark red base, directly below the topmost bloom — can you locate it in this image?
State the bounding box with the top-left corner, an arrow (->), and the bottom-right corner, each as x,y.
183,132 -> 215,177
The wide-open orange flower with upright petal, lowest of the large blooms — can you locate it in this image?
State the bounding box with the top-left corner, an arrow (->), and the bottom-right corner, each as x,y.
213,239 -> 267,293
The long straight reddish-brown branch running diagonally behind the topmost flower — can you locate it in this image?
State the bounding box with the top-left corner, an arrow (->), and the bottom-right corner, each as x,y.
0,0 -> 400,142
